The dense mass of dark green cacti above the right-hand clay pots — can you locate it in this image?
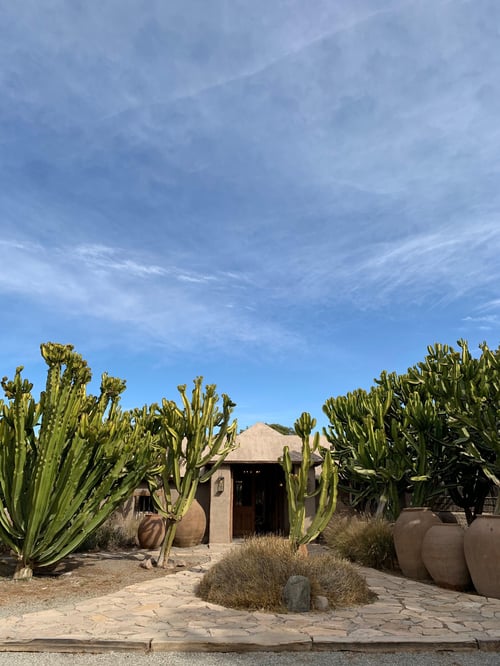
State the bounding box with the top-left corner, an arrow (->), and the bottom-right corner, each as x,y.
323,340 -> 500,523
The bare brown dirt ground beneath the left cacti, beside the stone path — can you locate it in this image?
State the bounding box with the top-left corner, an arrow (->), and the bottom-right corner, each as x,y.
0,550 -> 208,617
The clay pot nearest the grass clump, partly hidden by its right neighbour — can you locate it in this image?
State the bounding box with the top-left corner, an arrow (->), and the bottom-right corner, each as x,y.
393,507 -> 442,580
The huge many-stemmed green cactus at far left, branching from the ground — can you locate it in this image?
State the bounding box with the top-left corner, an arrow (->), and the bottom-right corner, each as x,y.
0,342 -> 151,579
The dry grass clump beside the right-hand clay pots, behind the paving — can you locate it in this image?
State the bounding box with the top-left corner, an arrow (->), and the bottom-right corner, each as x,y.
323,515 -> 397,570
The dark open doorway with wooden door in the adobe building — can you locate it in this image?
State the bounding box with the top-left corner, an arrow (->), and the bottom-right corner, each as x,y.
233,464 -> 285,538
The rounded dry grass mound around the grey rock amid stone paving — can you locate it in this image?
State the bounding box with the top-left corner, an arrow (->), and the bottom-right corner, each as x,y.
197,536 -> 376,612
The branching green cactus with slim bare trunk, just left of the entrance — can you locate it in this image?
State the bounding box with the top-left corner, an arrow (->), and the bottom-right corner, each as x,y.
141,377 -> 237,567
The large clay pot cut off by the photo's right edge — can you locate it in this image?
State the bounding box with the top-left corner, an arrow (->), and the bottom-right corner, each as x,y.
464,515 -> 500,599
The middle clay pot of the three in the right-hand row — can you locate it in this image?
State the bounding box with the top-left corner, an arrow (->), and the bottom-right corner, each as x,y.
422,523 -> 472,590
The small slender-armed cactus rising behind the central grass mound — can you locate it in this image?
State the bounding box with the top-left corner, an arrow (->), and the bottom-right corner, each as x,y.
280,412 -> 338,549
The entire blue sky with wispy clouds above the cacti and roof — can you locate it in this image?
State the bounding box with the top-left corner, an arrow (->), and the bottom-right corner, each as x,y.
0,0 -> 500,428
